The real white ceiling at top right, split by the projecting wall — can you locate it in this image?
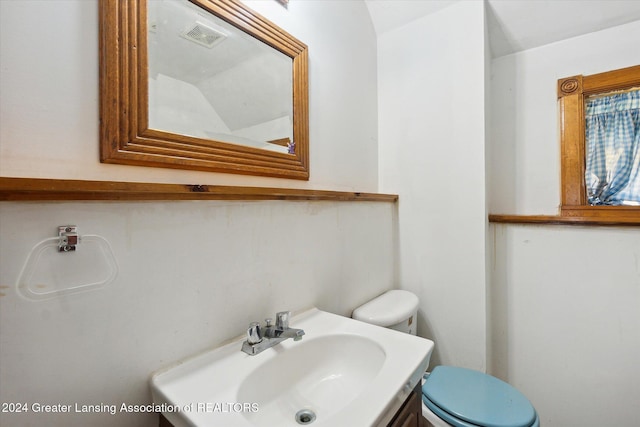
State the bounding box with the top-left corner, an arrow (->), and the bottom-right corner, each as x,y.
365,0 -> 640,57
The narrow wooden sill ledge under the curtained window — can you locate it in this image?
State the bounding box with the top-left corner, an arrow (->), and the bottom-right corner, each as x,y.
489,206 -> 640,226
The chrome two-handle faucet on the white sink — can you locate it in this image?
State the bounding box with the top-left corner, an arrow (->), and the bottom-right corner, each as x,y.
242,311 -> 304,356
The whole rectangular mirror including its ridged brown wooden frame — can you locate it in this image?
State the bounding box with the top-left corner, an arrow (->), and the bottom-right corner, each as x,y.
99,0 -> 309,180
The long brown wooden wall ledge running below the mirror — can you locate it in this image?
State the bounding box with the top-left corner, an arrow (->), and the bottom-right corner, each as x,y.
0,177 -> 398,202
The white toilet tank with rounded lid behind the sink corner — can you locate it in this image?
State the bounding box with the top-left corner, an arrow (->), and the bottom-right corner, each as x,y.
351,289 -> 418,335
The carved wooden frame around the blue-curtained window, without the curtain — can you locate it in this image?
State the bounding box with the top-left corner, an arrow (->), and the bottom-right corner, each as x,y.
558,65 -> 640,225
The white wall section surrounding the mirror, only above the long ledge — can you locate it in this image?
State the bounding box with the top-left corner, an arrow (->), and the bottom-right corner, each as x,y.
0,0 -> 378,192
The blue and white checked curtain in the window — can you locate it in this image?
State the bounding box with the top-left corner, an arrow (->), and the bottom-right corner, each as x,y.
585,89 -> 640,205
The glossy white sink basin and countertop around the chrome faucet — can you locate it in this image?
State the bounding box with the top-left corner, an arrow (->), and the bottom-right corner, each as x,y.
151,308 -> 433,427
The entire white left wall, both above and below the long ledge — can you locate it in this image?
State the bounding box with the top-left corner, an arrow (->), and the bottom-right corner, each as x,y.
0,0 -> 390,427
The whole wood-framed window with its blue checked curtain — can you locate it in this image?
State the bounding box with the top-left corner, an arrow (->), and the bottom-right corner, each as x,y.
558,66 -> 640,224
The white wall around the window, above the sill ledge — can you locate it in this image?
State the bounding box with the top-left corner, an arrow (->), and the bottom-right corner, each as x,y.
487,21 -> 640,215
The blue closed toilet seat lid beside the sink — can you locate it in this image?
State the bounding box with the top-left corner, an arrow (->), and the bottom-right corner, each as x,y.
422,366 -> 537,427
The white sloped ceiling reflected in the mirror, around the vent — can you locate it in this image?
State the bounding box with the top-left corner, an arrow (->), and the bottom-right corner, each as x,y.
149,0 -> 293,131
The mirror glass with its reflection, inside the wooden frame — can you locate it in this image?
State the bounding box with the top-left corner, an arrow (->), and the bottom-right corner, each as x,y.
147,0 -> 294,153
